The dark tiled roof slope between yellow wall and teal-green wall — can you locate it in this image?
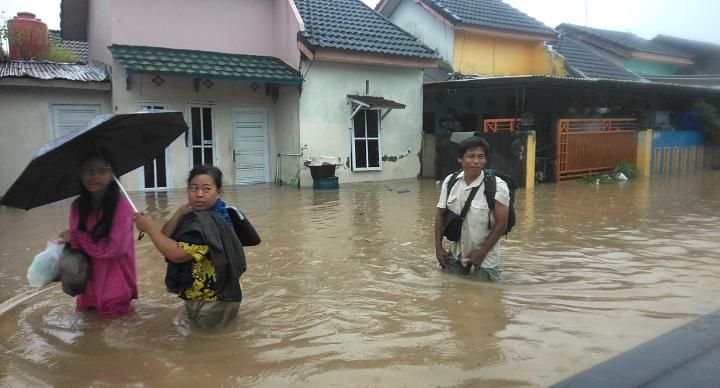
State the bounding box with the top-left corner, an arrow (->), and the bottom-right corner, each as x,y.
555,34 -> 642,80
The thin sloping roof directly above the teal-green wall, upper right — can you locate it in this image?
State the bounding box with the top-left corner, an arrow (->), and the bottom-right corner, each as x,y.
557,23 -> 692,59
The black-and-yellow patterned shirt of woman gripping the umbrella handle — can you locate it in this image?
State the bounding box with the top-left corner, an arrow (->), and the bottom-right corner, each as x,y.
178,242 -> 217,301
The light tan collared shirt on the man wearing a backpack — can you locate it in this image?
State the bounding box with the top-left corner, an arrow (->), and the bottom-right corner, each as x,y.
437,172 -> 510,268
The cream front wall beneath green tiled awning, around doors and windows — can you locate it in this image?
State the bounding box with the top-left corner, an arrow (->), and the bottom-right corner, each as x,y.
112,62 -> 298,190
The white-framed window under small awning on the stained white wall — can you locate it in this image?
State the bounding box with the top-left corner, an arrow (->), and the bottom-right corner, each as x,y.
352,109 -> 382,171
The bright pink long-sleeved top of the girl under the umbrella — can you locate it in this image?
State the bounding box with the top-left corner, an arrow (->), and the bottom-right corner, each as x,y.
70,196 -> 138,315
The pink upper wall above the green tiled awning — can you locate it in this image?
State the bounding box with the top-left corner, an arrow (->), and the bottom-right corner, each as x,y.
88,0 -> 300,69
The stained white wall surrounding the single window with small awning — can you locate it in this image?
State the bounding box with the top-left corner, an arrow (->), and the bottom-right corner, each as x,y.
300,61 -> 423,186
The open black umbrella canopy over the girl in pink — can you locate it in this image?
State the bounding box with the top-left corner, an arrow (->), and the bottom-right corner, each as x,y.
0,111 -> 188,210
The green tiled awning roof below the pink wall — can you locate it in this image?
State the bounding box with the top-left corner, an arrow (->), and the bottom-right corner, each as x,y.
109,45 -> 303,84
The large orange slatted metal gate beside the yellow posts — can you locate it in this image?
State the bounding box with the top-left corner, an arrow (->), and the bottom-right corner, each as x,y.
555,119 -> 637,182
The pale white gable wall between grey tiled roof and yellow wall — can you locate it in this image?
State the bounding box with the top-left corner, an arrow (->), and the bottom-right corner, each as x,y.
388,0 -> 455,63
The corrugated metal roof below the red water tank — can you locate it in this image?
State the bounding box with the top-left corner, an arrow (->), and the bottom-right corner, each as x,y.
0,61 -> 110,82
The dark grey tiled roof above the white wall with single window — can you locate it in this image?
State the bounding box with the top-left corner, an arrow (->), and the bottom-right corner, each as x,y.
295,0 -> 437,59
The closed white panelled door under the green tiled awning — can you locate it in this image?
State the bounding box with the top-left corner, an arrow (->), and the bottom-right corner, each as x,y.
232,108 -> 270,185
